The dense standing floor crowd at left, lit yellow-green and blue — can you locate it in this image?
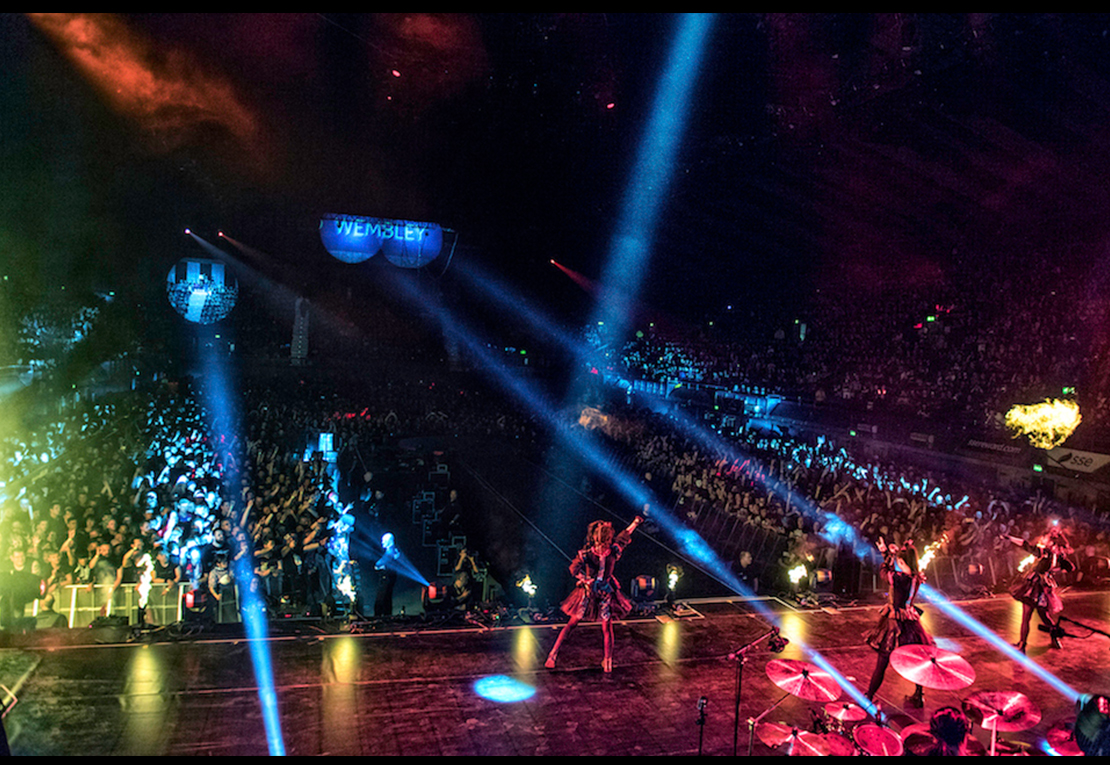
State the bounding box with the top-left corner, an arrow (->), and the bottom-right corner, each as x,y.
0,361 -> 546,626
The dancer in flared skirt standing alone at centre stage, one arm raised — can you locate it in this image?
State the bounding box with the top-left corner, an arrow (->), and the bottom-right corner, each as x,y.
544,515 -> 644,672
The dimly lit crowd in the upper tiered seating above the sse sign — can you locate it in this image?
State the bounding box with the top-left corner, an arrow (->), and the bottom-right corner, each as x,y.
599,252 -> 1110,439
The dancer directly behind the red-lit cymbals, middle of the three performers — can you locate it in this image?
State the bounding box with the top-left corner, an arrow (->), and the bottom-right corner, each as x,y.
865,537 -> 932,708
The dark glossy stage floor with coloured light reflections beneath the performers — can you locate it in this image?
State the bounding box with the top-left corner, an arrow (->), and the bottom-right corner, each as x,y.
0,592 -> 1110,756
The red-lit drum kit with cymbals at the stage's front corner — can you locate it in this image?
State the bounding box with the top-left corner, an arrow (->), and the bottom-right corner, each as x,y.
748,645 -> 1078,757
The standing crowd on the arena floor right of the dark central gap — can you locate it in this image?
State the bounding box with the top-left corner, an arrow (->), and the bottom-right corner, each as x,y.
607,411 -> 1110,595
